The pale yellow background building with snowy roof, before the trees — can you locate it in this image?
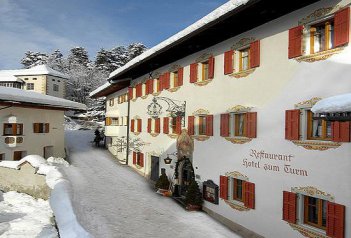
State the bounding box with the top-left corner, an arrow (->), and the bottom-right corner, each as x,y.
0,65 -> 68,98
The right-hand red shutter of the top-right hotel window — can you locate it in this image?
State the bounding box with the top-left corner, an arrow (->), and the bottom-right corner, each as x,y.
334,7 -> 350,47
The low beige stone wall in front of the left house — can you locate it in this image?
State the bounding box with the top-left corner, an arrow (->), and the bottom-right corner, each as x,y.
0,162 -> 50,200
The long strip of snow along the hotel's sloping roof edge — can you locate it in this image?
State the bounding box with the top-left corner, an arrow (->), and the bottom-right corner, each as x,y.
109,0 -> 249,78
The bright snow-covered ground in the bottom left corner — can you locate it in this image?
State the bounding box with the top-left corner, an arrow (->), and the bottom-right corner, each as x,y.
0,191 -> 58,238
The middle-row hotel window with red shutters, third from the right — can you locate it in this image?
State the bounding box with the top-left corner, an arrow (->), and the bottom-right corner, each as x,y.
188,115 -> 213,136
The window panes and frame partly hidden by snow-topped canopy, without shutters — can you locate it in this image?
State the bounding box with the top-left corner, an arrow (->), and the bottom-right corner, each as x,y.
307,110 -> 332,140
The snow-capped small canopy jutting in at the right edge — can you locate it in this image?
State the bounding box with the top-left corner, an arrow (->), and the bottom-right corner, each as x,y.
311,93 -> 351,113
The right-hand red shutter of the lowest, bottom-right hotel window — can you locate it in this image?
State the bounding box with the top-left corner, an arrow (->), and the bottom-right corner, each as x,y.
326,202 -> 345,238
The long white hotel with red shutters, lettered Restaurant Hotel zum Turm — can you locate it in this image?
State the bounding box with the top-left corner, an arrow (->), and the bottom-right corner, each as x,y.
91,0 -> 351,238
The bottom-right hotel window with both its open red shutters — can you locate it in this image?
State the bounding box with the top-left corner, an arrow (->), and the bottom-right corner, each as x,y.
283,188 -> 346,237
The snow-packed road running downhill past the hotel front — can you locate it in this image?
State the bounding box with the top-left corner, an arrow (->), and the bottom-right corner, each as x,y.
64,131 -> 239,238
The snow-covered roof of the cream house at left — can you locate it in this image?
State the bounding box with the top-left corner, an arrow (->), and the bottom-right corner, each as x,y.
0,86 -> 87,110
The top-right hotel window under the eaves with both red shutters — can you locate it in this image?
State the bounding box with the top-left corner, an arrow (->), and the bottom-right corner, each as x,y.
289,7 -> 350,59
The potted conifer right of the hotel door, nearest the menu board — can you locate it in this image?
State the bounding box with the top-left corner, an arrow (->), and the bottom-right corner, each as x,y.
185,179 -> 203,211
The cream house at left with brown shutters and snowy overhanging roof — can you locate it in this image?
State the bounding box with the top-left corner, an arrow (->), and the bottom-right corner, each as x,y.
0,87 -> 86,160
